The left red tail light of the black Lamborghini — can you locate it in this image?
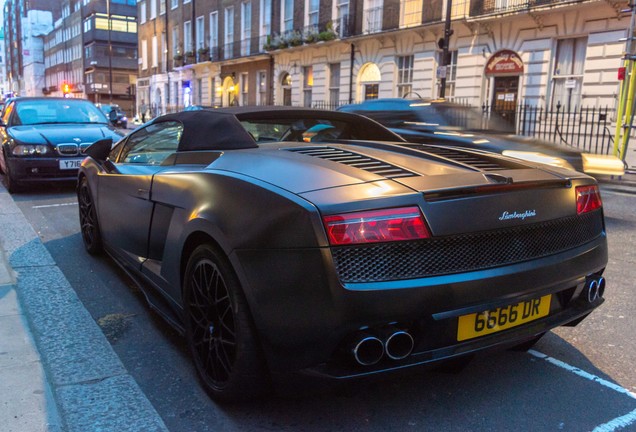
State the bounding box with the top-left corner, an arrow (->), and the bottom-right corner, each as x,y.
322,207 -> 431,246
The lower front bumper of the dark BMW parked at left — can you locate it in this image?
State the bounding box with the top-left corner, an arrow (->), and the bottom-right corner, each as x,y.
6,157 -> 83,184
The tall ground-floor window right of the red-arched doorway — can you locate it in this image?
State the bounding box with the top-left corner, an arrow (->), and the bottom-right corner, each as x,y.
552,37 -> 587,109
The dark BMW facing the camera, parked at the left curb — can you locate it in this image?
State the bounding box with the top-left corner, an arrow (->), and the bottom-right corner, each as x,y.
0,97 -> 123,192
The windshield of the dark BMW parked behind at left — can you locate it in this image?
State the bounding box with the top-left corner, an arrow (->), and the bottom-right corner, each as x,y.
13,99 -> 108,125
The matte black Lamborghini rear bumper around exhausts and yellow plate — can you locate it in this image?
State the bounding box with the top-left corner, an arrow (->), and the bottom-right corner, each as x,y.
232,234 -> 607,379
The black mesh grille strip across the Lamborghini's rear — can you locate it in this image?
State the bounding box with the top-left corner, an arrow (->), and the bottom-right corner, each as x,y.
331,211 -> 603,283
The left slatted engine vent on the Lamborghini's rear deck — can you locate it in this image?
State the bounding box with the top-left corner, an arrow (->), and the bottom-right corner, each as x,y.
287,147 -> 418,179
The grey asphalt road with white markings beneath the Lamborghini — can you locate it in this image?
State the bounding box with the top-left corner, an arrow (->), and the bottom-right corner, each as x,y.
8,186 -> 636,432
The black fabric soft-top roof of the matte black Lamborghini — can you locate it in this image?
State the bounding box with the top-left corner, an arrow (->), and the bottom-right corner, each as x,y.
152,110 -> 258,151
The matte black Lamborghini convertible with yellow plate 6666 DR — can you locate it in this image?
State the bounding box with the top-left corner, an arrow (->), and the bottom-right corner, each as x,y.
77,107 -> 608,401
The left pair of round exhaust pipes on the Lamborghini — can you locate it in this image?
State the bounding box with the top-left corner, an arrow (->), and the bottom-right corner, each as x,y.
350,327 -> 415,366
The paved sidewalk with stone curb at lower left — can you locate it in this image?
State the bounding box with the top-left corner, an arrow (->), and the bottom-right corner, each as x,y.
0,185 -> 168,432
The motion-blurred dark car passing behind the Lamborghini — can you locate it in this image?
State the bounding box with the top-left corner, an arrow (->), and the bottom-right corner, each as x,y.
338,98 -> 625,176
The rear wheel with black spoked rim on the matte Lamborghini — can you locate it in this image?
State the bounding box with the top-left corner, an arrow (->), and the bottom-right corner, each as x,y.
184,244 -> 267,402
